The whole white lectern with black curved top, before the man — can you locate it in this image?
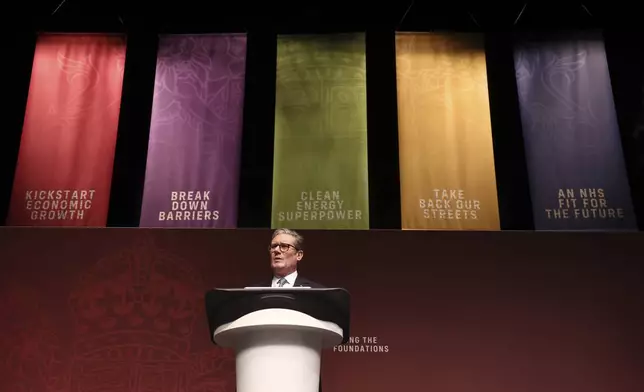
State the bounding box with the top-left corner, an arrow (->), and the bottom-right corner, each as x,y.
206,288 -> 349,392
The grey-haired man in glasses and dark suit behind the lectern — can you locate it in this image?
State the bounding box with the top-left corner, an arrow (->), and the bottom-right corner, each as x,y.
252,229 -> 324,288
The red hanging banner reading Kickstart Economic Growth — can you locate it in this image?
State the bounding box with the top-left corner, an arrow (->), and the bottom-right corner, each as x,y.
7,34 -> 126,226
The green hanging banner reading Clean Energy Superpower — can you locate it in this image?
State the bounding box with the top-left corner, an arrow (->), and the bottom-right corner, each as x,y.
271,34 -> 369,229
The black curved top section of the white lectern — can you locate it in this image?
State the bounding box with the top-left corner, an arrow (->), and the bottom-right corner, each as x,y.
205,287 -> 351,344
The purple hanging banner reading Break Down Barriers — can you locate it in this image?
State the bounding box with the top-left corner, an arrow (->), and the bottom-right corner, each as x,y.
140,34 -> 246,228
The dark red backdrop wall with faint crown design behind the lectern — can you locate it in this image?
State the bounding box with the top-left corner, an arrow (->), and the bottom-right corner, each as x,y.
0,228 -> 644,392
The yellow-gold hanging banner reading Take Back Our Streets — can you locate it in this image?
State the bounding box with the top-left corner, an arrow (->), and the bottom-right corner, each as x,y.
396,33 -> 500,230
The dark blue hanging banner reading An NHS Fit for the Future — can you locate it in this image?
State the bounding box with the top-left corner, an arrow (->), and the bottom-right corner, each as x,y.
514,33 -> 637,230
